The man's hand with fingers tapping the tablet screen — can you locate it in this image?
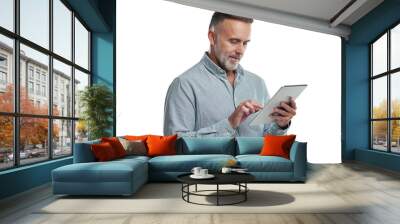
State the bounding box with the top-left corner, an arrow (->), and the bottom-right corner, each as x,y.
228,100 -> 263,129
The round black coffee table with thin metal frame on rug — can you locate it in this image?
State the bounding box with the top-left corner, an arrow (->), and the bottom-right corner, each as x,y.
177,173 -> 255,206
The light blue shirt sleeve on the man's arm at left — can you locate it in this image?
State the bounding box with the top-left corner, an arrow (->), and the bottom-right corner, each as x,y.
164,78 -> 236,137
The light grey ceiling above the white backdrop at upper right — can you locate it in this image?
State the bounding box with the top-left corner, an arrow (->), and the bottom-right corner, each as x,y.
168,0 -> 383,38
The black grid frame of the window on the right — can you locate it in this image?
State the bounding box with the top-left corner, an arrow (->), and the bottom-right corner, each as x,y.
368,21 -> 400,155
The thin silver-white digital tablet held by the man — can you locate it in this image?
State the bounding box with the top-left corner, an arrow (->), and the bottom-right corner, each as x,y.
250,85 -> 307,126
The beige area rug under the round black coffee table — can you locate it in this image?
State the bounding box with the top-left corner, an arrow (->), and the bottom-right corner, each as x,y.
36,183 -> 360,214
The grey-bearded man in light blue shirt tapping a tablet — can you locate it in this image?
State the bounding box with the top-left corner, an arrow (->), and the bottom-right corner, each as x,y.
164,12 -> 296,137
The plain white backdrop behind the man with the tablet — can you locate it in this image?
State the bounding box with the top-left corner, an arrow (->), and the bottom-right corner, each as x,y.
116,0 -> 341,163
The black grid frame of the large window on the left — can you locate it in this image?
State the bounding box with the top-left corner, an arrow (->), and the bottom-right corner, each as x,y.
0,0 -> 93,172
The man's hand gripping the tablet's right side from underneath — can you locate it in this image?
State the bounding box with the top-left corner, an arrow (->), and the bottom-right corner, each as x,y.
270,97 -> 297,129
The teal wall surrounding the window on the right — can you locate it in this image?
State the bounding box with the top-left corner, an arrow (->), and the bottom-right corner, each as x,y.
342,0 -> 400,170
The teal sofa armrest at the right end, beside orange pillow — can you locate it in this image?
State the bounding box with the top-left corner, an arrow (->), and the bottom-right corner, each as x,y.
290,141 -> 307,181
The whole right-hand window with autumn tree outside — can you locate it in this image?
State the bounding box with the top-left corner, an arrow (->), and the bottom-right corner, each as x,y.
370,25 -> 400,153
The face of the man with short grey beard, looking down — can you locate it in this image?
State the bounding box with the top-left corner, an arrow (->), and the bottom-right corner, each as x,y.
210,19 -> 251,71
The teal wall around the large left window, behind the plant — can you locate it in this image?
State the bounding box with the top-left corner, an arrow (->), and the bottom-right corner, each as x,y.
0,0 -> 116,199
